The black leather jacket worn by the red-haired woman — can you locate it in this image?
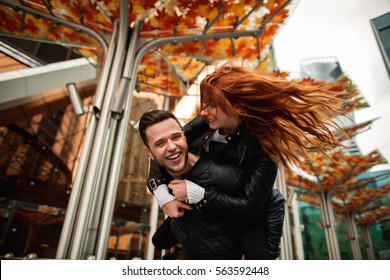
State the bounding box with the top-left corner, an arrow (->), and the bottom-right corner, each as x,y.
184,117 -> 278,214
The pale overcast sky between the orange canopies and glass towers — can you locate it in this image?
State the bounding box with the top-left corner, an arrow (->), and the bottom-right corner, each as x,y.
274,0 -> 390,171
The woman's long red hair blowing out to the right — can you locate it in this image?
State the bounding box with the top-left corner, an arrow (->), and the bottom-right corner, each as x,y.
200,63 -> 344,166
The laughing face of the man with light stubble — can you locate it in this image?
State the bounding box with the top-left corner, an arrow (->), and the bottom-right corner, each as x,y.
145,119 -> 188,176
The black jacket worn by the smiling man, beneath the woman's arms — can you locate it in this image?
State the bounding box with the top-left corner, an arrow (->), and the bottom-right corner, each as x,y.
161,156 -> 245,260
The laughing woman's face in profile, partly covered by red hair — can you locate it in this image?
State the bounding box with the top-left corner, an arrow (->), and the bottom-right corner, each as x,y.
200,103 -> 239,135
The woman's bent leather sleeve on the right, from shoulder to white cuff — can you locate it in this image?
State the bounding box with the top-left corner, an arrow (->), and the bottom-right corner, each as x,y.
196,145 -> 277,217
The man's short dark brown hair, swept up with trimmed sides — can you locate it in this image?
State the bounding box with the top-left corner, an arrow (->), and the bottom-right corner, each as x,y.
138,110 -> 181,148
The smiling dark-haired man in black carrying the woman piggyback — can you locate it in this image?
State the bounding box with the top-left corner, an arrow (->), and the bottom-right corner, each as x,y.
140,110 -> 243,259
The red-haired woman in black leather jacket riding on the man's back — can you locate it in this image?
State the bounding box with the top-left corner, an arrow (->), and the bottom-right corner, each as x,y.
152,63 -> 342,259
